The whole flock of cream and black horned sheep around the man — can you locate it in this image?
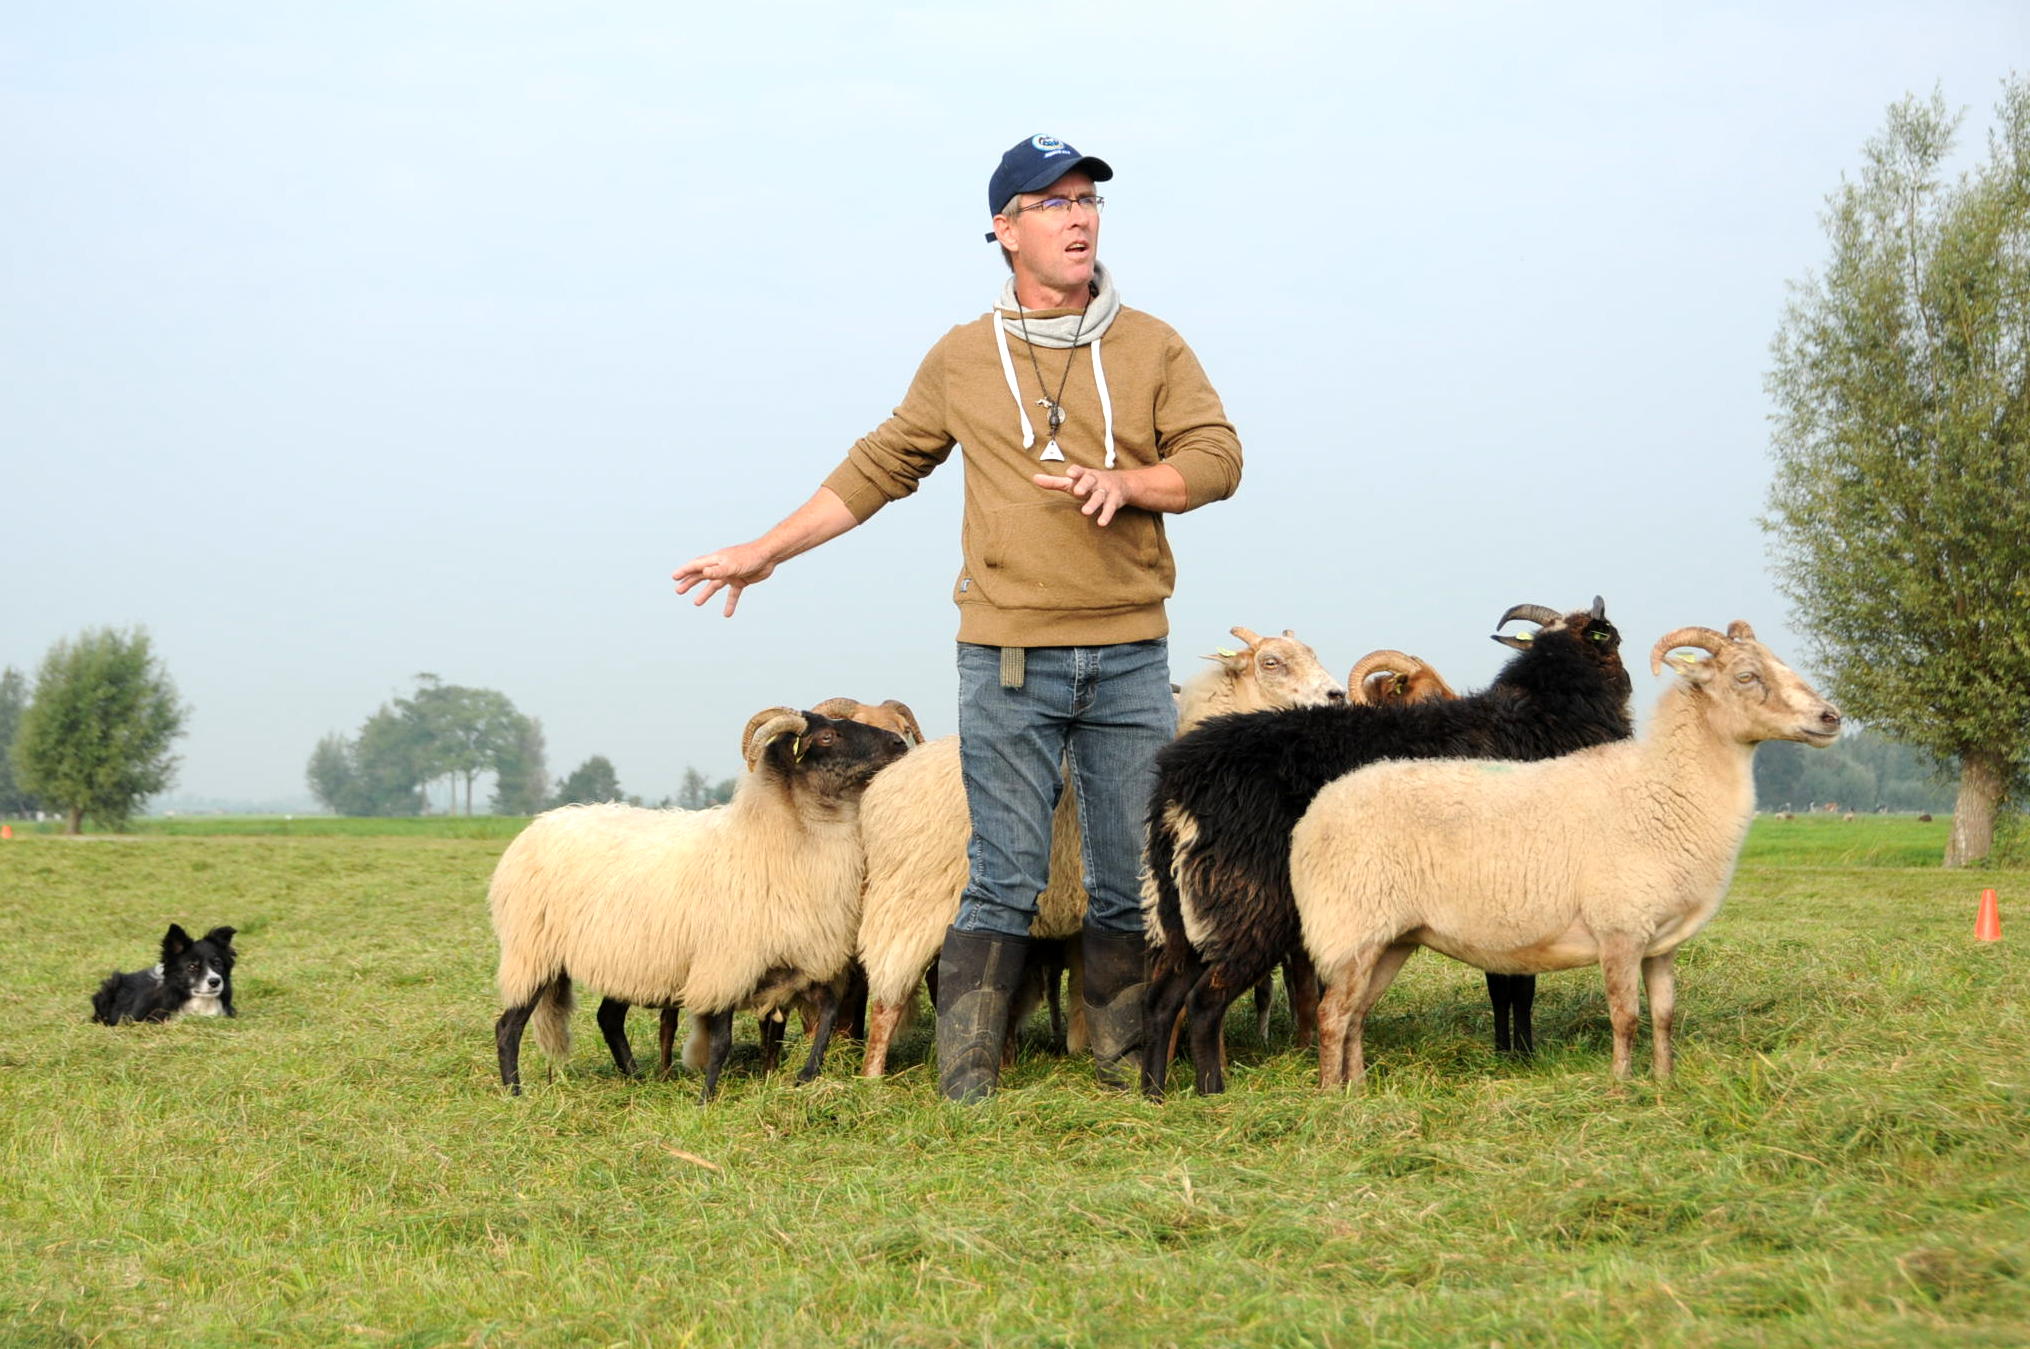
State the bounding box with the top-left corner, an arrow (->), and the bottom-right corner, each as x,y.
487,598 -> 1841,1099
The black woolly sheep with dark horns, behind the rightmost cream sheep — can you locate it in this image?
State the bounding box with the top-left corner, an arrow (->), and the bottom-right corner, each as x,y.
1143,596 -> 1632,1099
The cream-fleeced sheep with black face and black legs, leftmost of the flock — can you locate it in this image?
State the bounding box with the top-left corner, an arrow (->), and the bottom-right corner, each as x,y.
487,708 -> 903,1099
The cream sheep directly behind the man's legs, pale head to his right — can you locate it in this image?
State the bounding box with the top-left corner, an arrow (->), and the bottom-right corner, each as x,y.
859,627 -> 1346,1077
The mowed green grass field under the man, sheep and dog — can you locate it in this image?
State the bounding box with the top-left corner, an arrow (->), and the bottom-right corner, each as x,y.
0,820 -> 2030,1347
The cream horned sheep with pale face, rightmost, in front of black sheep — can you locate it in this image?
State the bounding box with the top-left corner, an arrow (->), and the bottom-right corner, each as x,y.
1291,621 -> 1841,1087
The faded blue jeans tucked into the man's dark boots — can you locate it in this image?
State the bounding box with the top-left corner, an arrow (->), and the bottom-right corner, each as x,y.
954,639 -> 1177,937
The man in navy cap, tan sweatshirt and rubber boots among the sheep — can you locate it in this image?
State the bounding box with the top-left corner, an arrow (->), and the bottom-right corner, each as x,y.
672,136 -> 1240,1102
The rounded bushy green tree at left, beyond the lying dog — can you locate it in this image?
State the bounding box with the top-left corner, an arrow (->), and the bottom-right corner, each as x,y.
12,627 -> 189,834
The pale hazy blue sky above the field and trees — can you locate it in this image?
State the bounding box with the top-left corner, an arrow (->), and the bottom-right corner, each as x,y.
0,0 -> 2030,809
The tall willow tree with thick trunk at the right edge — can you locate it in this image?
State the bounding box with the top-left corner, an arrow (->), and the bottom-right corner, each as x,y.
1762,79 -> 2030,866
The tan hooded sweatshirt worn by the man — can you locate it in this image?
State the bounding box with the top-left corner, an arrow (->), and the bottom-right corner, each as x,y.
824,306 -> 1240,647
